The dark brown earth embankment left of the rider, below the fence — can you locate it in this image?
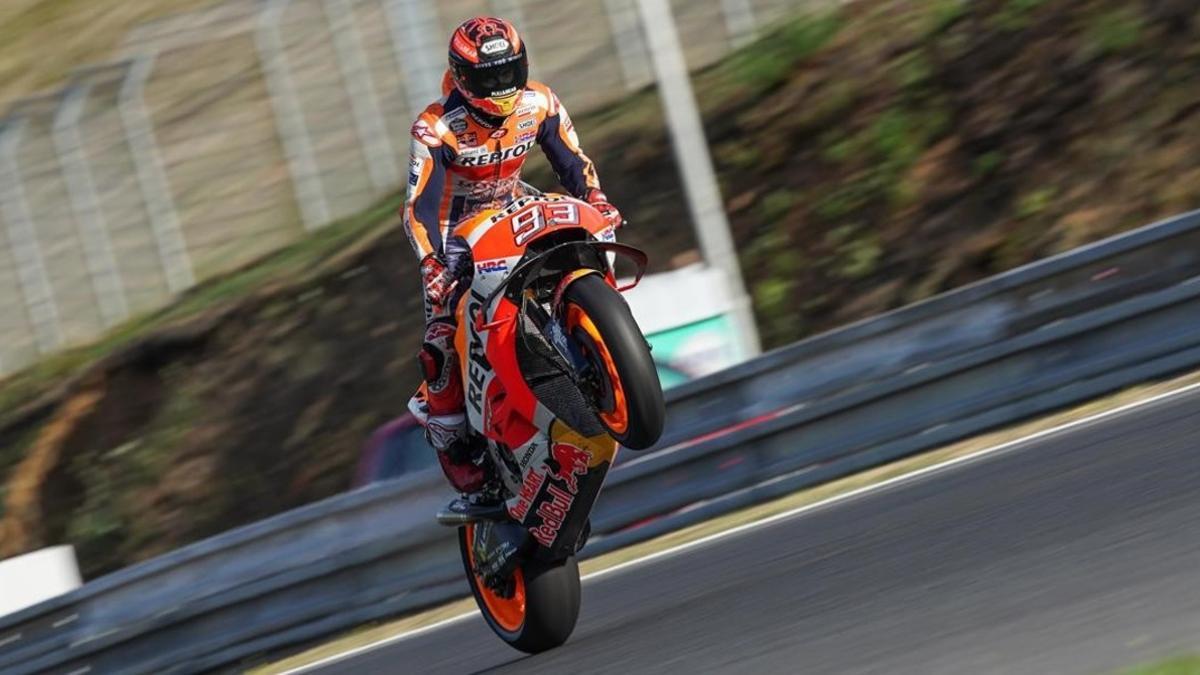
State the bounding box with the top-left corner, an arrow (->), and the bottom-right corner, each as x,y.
0,229 -> 420,575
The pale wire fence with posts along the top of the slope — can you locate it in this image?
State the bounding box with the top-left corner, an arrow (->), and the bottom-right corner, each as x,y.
0,0 -> 802,374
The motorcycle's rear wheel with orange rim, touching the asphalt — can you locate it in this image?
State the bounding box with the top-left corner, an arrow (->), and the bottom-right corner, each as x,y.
458,524 -> 581,653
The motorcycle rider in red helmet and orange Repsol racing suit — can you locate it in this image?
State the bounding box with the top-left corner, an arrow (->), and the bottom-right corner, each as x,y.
404,17 -> 622,494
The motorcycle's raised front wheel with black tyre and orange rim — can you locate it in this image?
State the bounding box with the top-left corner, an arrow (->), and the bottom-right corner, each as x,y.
560,274 -> 666,450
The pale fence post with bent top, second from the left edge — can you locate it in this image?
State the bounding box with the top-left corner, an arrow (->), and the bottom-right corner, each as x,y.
53,84 -> 130,328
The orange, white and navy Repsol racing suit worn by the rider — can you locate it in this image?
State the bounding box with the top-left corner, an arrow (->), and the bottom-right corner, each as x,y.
404,82 -> 619,492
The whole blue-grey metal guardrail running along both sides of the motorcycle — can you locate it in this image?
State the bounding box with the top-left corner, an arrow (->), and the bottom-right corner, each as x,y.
7,211 -> 1200,673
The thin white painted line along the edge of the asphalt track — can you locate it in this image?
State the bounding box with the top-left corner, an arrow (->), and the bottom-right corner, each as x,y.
281,383 -> 1200,675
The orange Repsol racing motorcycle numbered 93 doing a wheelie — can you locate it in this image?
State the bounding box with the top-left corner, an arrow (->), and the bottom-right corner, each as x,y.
409,187 -> 665,653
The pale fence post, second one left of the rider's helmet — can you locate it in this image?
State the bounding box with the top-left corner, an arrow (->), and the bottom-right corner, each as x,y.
322,0 -> 400,193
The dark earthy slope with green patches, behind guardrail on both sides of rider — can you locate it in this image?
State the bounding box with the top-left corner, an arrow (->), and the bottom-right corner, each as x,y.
7,0 -> 1200,575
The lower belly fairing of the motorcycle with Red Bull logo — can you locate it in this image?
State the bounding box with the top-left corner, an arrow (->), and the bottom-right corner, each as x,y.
509,420 -> 617,557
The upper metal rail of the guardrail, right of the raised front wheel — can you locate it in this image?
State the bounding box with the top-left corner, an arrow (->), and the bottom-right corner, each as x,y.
658,205 -> 1200,448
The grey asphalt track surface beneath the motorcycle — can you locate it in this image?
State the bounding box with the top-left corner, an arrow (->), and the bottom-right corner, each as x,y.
318,386 -> 1200,675
